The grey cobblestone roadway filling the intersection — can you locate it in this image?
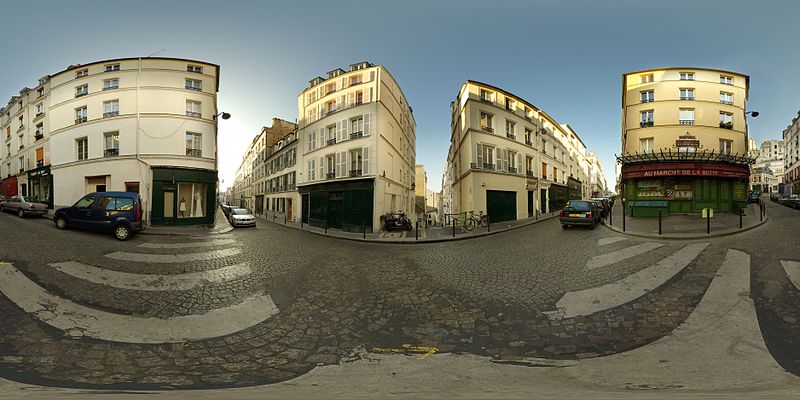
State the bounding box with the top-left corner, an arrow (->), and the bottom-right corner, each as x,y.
0,206 -> 800,389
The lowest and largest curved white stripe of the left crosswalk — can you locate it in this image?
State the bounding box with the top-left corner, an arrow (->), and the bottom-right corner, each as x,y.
0,264 -> 278,344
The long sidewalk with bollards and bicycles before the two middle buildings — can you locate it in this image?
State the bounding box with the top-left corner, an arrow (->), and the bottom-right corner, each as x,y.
256,211 -> 558,244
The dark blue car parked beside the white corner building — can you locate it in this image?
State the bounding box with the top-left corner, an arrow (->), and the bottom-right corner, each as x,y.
53,192 -> 145,240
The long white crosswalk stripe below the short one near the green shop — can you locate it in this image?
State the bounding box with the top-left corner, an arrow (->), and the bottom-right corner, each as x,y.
550,243 -> 708,318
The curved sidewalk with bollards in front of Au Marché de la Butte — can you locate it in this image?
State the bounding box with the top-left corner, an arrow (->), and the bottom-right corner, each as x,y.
603,201 -> 769,239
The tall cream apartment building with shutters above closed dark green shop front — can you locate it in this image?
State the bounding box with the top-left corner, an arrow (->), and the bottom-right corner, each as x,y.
297,62 -> 416,232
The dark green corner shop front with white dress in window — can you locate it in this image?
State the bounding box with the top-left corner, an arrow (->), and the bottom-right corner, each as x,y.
150,167 -> 217,225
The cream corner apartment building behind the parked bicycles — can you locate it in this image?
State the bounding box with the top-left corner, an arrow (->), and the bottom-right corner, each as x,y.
441,80 -> 586,222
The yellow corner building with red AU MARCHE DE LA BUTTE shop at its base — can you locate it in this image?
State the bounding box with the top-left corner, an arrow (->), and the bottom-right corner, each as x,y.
617,68 -> 754,216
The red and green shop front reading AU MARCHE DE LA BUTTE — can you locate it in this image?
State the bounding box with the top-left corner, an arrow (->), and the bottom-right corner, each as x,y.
622,159 -> 750,217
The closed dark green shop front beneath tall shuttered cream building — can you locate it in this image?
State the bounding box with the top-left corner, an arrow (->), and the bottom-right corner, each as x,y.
298,178 -> 374,232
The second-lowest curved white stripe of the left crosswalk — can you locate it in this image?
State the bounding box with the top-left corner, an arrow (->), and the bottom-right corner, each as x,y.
50,261 -> 252,291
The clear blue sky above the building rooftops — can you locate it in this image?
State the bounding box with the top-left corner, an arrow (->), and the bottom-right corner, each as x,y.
0,0 -> 800,190
